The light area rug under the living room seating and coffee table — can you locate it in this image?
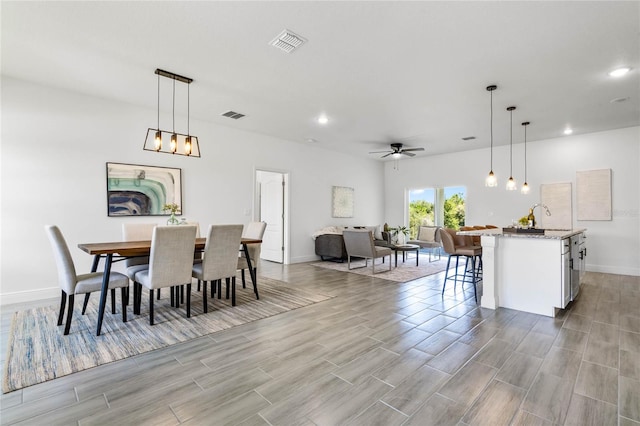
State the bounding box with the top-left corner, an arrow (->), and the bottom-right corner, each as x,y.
311,253 -> 447,283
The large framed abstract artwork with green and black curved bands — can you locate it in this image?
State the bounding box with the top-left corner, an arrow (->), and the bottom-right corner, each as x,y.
107,163 -> 182,216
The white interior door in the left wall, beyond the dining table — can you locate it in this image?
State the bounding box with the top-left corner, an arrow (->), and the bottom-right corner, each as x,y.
258,171 -> 284,263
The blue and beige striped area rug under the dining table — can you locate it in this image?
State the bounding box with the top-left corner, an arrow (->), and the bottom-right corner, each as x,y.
2,277 -> 333,393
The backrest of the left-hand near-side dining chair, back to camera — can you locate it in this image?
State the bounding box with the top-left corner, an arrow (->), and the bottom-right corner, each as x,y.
149,225 -> 196,288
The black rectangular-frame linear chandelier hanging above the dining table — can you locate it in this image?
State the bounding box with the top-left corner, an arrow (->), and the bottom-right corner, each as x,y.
143,69 -> 200,157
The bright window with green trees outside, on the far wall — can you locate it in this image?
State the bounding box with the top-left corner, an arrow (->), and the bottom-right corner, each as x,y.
408,186 -> 467,238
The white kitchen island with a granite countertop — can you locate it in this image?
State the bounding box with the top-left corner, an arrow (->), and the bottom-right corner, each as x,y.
459,229 -> 585,317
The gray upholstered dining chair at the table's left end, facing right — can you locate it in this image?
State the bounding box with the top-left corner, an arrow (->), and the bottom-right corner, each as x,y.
45,225 -> 129,335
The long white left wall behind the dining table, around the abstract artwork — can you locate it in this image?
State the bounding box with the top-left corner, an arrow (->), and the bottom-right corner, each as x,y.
0,77 -> 384,304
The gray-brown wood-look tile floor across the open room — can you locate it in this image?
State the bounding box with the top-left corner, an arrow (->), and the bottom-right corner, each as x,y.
0,262 -> 640,426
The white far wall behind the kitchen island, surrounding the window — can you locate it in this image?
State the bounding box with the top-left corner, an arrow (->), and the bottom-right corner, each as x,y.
385,127 -> 640,275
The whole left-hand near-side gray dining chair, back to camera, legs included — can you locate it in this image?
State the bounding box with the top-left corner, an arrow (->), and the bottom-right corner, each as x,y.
134,225 -> 196,325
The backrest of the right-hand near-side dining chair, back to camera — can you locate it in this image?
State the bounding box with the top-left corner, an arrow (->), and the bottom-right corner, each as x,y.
202,225 -> 242,281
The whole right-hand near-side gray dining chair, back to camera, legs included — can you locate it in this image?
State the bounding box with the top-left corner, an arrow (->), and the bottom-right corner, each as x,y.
191,225 -> 242,312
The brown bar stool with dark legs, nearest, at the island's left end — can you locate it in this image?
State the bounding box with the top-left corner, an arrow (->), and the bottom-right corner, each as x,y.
440,228 -> 482,302
